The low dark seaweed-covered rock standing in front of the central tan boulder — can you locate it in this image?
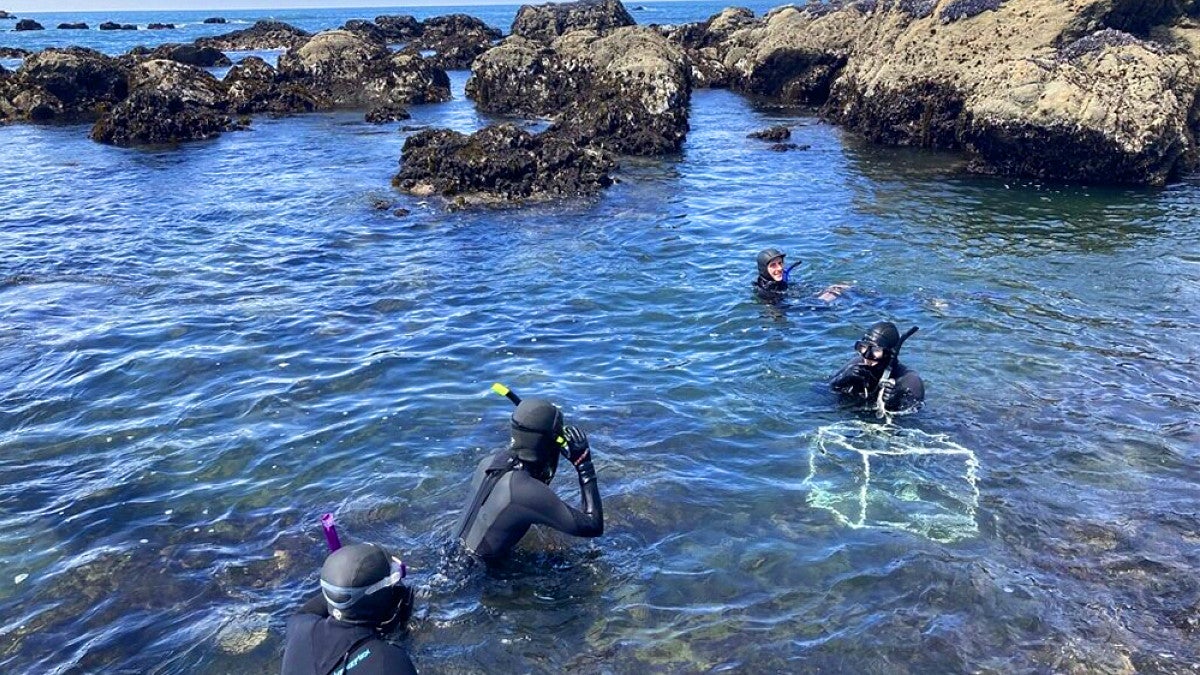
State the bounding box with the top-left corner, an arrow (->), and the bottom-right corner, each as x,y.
392,124 -> 617,205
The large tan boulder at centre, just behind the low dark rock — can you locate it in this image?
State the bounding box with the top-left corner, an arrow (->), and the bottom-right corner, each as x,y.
467,26 -> 691,155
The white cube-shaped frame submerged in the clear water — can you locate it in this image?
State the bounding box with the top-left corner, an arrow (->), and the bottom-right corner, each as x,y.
804,422 -> 979,543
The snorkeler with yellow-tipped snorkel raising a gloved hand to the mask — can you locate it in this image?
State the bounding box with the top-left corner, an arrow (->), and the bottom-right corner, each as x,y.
455,399 -> 604,558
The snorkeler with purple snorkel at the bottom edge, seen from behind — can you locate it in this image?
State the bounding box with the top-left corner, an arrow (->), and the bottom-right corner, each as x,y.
283,544 -> 416,675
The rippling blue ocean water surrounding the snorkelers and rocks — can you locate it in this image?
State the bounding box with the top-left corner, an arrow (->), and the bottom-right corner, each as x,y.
0,2 -> 1200,674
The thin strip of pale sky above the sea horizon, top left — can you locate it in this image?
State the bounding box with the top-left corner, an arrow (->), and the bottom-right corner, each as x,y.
0,0 -> 525,14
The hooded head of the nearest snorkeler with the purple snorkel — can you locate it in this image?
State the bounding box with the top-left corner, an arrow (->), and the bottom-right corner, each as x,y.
320,544 -> 413,631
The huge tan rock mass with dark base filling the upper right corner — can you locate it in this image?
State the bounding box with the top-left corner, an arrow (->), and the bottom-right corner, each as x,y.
715,0 -> 1200,185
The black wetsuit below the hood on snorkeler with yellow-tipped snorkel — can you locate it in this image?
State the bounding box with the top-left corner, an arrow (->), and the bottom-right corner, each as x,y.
455,449 -> 604,557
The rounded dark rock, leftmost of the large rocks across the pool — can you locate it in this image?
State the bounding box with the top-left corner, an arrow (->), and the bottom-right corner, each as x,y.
17,47 -> 128,119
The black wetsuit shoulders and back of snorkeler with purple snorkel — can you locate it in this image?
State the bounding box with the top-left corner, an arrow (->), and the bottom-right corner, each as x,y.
283,595 -> 416,675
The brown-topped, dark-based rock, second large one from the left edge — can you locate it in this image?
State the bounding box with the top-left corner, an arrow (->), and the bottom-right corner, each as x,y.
91,59 -> 239,145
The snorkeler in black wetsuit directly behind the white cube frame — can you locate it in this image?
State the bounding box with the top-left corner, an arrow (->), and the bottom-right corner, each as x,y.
829,321 -> 925,412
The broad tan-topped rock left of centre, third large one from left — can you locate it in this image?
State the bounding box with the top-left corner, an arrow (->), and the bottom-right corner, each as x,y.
278,30 -> 450,107
